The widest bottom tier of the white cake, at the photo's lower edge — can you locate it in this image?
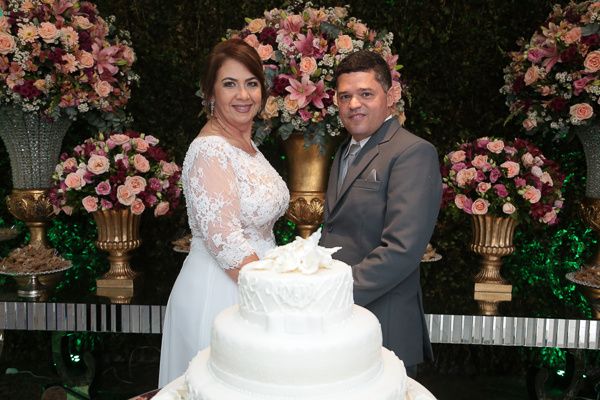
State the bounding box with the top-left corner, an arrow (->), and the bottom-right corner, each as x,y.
181,348 -> 408,400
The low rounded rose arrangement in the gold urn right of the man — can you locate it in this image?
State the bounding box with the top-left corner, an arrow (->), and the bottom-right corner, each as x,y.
441,137 -> 565,225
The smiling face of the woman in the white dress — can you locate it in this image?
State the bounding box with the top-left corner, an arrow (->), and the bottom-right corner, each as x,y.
214,59 -> 262,128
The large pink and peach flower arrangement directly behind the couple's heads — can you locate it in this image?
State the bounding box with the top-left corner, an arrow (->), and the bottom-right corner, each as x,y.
227,3 -> 405,144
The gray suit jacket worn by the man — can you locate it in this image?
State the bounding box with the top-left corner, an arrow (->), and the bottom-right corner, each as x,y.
320,118 -> 442,365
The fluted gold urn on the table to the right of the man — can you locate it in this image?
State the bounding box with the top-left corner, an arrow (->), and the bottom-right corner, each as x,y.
471,215 -> 517,293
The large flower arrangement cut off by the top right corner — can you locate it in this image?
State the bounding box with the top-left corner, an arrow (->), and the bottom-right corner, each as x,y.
501,1 -> 600,140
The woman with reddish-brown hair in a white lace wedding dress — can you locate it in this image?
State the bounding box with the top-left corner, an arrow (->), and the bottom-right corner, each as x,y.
159,39 -> 289,387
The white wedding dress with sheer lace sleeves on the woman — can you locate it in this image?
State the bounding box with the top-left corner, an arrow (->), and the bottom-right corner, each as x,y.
159,136 -> 289,387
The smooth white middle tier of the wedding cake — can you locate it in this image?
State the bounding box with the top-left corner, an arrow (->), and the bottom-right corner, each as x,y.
199,305 -> 382,395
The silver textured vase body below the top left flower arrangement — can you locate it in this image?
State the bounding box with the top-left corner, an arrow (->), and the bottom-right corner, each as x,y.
0,106 -> 71,189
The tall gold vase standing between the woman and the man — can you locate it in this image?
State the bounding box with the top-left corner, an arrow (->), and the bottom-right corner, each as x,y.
283,133 -> 339,238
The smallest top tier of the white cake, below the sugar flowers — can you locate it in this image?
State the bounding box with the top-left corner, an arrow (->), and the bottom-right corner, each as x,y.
239,260 -> 354,334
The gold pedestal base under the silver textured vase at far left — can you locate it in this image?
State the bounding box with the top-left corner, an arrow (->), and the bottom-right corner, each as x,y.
6,189 -> 53,247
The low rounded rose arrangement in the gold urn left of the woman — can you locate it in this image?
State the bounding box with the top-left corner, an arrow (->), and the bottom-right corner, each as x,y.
49,130 -> 181,217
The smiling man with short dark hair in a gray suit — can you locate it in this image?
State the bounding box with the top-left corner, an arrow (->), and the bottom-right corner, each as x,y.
320,50 -> 442,378
